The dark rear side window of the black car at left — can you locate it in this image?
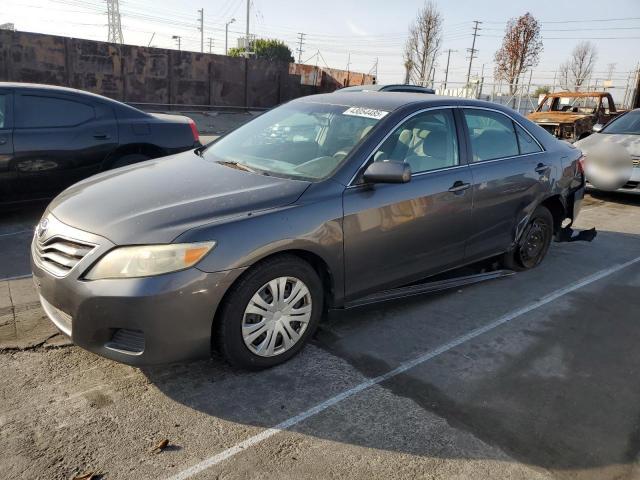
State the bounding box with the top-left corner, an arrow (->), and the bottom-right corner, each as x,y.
16,95 -> 95,128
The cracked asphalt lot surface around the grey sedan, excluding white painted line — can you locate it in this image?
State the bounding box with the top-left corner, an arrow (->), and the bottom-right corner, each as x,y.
0,191 -> 640,480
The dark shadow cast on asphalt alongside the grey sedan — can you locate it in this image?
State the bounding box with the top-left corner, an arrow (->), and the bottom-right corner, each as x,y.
143,232 -> 640,479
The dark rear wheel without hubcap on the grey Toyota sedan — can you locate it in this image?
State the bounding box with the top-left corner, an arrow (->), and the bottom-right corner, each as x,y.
502,206 -> 553,271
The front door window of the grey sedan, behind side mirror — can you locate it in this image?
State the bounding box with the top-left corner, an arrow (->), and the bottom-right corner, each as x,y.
373,109 -> 458,173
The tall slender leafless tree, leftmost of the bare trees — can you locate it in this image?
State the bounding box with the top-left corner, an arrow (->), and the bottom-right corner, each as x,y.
403,0 -> 443,85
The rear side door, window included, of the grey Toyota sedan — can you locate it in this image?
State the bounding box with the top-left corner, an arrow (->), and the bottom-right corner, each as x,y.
462,108 -> 552,261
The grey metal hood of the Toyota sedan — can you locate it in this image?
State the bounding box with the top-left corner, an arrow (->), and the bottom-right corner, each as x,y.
48,151 -> 309,245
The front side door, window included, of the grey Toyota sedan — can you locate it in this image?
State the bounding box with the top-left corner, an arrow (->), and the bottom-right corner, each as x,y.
343,108 -> 472,300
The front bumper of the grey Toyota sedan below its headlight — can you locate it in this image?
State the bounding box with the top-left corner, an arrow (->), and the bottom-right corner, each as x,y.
31,216 -> 244,366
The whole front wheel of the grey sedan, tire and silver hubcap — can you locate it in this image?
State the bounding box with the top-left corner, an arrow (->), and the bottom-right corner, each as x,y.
214,255 -> 323,370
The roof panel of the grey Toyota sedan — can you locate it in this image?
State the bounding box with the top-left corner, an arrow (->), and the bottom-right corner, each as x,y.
292,91 -> 508,115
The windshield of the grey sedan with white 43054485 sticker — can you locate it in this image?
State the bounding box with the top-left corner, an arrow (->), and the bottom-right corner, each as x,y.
202,102 -> 387,181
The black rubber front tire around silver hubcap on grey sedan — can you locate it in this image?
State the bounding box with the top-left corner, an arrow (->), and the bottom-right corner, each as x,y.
213,255 -> 324,370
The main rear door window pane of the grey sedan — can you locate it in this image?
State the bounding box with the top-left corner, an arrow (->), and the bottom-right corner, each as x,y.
464,109 -> 518,162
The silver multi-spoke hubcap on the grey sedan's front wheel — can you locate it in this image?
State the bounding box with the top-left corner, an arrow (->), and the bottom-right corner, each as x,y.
242,277 -> 311,357
